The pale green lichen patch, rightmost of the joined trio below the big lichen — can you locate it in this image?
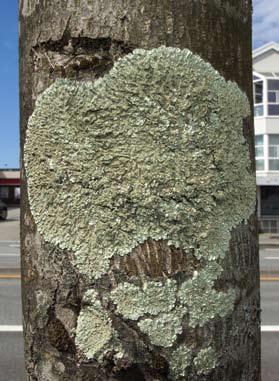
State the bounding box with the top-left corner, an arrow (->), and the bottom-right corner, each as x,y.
178,262 -> 236,327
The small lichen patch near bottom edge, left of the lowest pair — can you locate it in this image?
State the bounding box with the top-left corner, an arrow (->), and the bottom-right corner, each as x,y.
169,345 -> 193,380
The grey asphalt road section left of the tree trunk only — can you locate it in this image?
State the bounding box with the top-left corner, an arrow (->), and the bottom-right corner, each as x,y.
0,208 -> 25,381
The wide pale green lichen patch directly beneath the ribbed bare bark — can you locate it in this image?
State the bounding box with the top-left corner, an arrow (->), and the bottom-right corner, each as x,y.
110,279 -> 177,320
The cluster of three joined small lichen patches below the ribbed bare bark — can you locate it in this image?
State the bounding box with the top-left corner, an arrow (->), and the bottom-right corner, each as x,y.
110,262 -> 236,347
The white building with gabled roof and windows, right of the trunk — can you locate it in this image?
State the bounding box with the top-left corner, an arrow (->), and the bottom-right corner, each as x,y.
253,42 -> 279,233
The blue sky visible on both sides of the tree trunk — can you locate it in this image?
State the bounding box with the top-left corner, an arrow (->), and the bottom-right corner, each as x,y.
0,0 -> 279,168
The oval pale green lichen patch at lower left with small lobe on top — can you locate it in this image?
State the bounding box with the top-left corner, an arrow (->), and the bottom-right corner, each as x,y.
76,290 -> 114,358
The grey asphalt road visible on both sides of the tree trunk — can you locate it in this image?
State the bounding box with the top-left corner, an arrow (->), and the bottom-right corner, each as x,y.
0,209 -> 279,381
